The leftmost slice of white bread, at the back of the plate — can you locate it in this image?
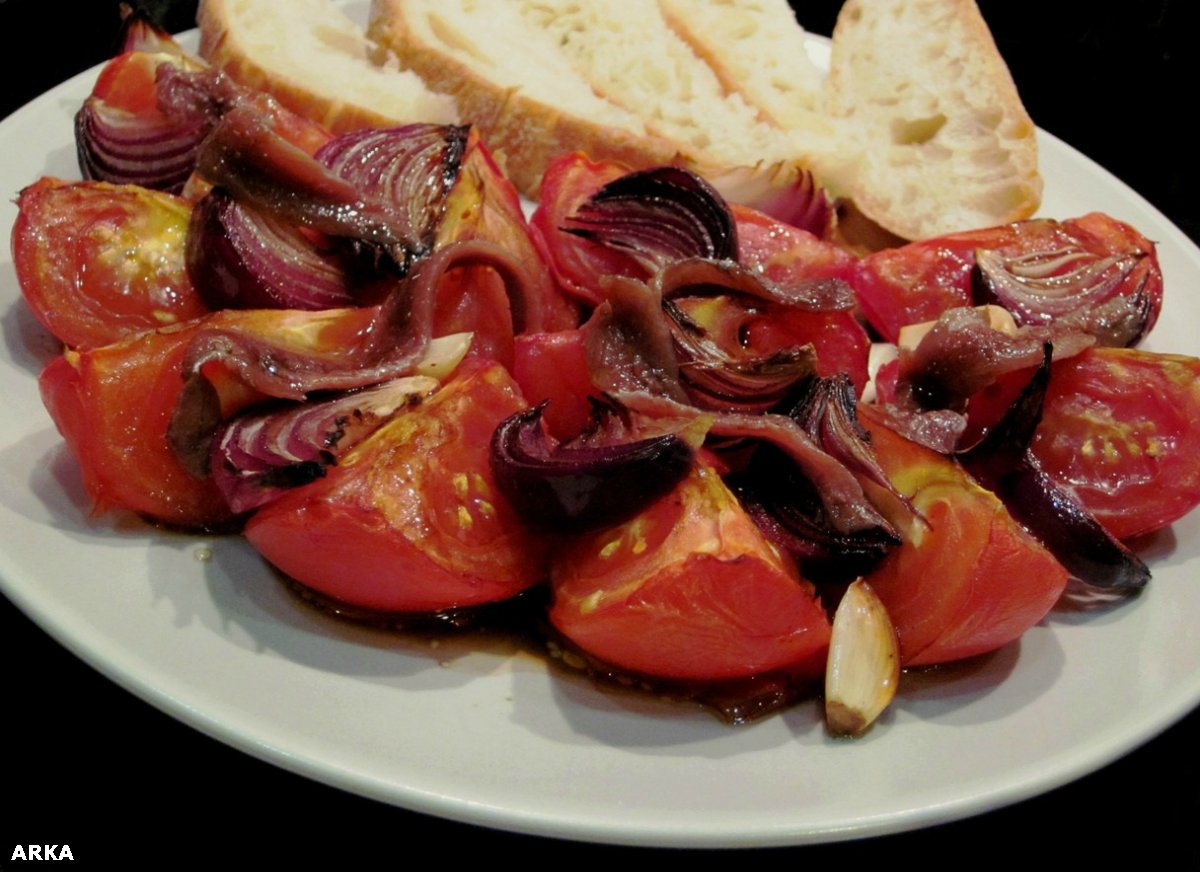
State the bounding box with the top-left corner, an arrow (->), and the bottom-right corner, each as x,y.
197,0 -> 457,133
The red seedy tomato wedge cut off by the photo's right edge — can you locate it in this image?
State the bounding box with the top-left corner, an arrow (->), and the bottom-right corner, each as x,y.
1031,348 -> 1200,539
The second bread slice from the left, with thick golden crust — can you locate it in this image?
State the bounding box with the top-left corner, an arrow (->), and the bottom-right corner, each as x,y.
367,0 -> 678,197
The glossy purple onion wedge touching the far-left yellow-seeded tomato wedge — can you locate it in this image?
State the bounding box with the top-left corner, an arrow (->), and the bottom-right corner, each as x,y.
187,190 -> 355,309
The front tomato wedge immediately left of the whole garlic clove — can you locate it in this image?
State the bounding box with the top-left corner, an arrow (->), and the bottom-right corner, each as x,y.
550,468 -> 829,681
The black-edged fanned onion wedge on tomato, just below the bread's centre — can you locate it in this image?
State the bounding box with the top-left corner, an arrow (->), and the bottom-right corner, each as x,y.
562,167 -> 738,270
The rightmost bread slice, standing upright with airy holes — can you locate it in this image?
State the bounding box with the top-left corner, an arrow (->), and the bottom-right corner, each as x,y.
826,0 -> 1042,239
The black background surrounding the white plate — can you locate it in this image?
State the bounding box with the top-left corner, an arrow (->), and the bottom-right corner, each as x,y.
0,0 -> 1200,868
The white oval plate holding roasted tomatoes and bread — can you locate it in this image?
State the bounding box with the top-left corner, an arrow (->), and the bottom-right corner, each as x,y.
0,25 -> 1200,847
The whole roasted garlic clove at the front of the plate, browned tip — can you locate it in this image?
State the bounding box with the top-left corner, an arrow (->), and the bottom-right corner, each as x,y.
826,578 -> 900,735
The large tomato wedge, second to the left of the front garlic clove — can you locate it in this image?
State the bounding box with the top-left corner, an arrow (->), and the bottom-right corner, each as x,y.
246,361 -> 546,613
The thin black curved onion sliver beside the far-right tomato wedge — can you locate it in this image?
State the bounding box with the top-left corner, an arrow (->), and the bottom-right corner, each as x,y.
959,345 -> 1150,594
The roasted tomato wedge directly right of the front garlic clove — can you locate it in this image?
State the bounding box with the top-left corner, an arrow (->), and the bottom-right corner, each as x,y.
859,407 -> 1067,666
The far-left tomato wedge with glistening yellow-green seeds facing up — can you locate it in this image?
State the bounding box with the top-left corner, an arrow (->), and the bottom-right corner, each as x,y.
12,179 -> 208,348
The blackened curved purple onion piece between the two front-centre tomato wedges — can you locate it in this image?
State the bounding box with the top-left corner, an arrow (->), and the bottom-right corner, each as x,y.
492,403 -> 692,533
